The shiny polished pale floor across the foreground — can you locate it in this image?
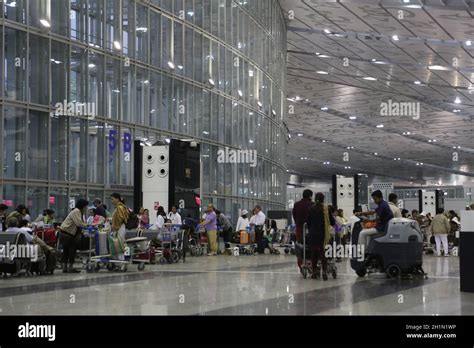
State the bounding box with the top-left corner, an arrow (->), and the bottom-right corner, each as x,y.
0,255 -> 474,315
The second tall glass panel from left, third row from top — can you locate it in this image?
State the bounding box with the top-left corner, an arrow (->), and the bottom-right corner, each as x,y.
27,110 -> 49,179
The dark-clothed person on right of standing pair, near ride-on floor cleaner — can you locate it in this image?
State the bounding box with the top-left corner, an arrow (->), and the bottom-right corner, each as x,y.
306,192 -> 336,280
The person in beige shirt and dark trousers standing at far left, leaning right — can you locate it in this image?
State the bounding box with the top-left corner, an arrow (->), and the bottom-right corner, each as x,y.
59,198 -> 89,273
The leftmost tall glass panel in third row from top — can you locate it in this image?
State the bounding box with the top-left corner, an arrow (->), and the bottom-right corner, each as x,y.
3,106 -> 27,178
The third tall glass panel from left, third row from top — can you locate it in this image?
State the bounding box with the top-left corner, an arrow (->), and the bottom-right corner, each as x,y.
50,115 -> 68,181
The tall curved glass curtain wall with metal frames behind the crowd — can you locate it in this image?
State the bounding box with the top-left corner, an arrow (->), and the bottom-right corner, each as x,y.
0,0 -> 287,220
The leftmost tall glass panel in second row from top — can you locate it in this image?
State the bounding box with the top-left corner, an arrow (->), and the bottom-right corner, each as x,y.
4,28 -> 26,100
